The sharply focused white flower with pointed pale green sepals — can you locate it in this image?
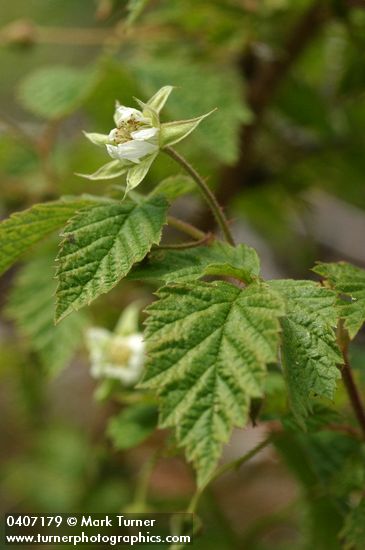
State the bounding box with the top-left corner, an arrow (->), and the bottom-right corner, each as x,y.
78,86 -> 213,199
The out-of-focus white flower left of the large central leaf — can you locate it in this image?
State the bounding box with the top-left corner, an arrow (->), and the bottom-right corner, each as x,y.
86,304 -> 145,387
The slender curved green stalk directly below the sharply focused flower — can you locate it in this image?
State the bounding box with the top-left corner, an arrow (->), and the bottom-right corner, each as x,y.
163,147 -> 235,246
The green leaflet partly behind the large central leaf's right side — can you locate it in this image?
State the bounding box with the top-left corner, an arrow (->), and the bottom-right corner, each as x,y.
269,280 -> 342,423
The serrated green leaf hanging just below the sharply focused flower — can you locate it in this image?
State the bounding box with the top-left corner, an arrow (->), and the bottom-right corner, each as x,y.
56,197 -> 168,321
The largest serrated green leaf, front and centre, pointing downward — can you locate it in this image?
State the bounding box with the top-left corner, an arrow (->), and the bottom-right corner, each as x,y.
142,281 -> 283,485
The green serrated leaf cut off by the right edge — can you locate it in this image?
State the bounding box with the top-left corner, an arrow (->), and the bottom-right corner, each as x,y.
313,262 -> 365,339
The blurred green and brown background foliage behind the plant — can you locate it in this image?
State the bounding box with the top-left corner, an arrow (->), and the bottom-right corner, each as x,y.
0,0 -> 365,550
